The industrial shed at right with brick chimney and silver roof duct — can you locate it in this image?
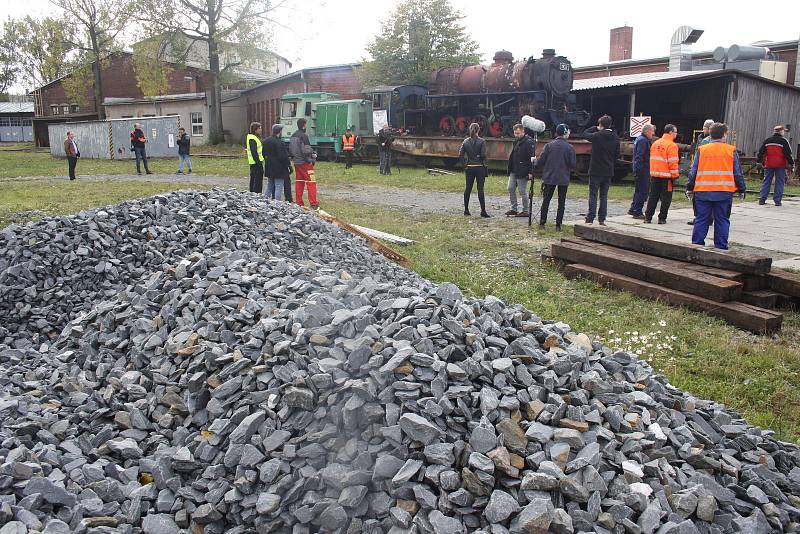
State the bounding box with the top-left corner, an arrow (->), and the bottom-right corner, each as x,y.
573,26 -> 800,157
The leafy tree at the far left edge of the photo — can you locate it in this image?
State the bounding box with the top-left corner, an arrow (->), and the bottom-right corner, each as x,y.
0,16 -> 74,87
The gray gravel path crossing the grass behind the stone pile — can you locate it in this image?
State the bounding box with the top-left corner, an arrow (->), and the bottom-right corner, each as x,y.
10,174 -> 627,224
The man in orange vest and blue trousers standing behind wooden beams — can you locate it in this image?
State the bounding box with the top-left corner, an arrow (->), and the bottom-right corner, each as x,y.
686,122 -> 745,250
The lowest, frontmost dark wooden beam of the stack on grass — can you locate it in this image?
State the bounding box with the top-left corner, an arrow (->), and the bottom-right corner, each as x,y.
564,264 -> 783,334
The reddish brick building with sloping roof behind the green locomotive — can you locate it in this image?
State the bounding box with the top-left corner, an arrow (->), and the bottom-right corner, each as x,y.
242,63 -> 363,132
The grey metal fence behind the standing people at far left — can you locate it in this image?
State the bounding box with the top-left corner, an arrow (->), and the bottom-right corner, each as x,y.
48,115 -> 180,159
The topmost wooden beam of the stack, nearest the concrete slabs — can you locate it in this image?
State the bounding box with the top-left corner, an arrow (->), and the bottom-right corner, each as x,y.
575,224 -> 772,274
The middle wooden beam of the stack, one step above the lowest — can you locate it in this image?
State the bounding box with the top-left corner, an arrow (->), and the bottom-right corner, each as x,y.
551,241 -> 742,302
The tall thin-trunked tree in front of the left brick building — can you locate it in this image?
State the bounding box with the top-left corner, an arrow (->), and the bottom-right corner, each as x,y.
51,0 -> 136,119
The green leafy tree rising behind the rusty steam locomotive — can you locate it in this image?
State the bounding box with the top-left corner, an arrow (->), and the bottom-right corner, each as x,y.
360,0 -> 480,85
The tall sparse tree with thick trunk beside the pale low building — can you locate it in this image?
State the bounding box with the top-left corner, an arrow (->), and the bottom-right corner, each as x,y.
137,0 -> 274,143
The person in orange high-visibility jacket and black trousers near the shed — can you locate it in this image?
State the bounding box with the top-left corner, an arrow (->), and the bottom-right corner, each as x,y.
644,124 -> 680,224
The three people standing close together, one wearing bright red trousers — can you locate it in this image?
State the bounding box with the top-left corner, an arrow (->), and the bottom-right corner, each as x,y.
245,119 -> 319,209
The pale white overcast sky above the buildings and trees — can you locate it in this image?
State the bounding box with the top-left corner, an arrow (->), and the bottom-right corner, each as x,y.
0,0 -> 800,79
